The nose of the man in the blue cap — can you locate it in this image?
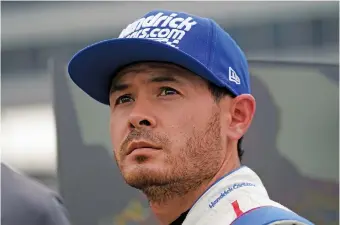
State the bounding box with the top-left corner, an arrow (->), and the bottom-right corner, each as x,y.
129,101 -> 156,129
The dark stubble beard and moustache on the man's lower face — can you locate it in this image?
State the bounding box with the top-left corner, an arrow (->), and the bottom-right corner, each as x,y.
118,112 -> 222,203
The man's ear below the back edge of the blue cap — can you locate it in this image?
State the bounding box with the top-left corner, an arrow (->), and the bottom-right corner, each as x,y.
227,94 -> 256,140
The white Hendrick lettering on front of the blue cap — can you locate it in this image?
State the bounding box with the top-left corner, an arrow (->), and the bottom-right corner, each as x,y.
119,12 -> 197,48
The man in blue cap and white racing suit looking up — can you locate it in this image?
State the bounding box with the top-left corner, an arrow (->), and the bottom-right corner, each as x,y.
68,10 -> 312,225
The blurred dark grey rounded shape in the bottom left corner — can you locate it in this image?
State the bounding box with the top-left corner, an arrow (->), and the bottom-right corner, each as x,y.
1,163 -> 70,225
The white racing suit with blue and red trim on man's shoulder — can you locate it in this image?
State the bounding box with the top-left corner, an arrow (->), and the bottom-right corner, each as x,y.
183,166 -> 313,225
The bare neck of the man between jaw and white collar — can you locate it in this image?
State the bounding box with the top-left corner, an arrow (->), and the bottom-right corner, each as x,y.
150,163 -> 240,225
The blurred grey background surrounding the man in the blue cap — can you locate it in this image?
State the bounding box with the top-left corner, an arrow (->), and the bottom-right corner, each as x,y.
1,1 -> 339,225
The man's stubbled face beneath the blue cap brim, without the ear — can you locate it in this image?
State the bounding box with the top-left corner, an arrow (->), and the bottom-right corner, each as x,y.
110,63 -> 226,201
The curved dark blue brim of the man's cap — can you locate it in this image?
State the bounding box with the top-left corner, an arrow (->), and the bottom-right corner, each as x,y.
68,38 -> 222,105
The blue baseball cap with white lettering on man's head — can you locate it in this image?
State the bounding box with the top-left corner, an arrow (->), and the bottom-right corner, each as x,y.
68,10 -> 250,105
